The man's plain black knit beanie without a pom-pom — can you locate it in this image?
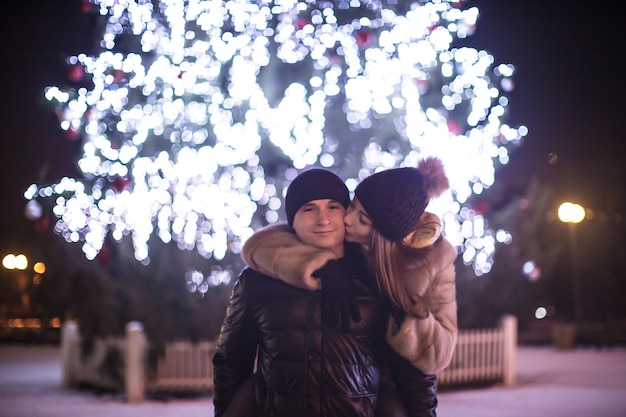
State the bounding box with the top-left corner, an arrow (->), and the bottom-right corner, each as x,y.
285,168 -> 350,227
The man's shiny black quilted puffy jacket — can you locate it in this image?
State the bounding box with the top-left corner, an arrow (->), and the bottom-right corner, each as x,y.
213,244 -> 436,417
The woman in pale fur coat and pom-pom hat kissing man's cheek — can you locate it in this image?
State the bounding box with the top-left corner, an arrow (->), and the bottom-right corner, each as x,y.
242,157 -> 458,374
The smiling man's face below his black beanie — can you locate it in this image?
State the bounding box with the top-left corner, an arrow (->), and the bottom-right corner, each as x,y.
293,199 -> 346,256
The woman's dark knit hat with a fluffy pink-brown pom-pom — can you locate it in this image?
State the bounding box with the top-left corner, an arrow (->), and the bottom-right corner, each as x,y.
354,157 -> 449,242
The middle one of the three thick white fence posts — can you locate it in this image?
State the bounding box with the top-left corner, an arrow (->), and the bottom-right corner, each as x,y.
125,321 -> 146,403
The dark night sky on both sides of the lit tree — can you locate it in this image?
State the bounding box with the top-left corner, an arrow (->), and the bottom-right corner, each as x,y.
0,0 -> 626,253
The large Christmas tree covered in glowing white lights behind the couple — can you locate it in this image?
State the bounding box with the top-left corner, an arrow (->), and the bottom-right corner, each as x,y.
26,0 -> 527,338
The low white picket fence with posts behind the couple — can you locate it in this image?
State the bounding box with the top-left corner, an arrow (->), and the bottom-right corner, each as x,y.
61,316 -> 517,402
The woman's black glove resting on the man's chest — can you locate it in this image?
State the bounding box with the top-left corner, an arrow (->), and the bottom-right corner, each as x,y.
313,260 -> 361,332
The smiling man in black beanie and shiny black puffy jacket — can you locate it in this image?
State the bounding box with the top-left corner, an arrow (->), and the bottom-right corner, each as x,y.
213,169 -> 432,417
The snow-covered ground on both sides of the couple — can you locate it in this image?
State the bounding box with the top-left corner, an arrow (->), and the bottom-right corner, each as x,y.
0,343 -> 626,417
